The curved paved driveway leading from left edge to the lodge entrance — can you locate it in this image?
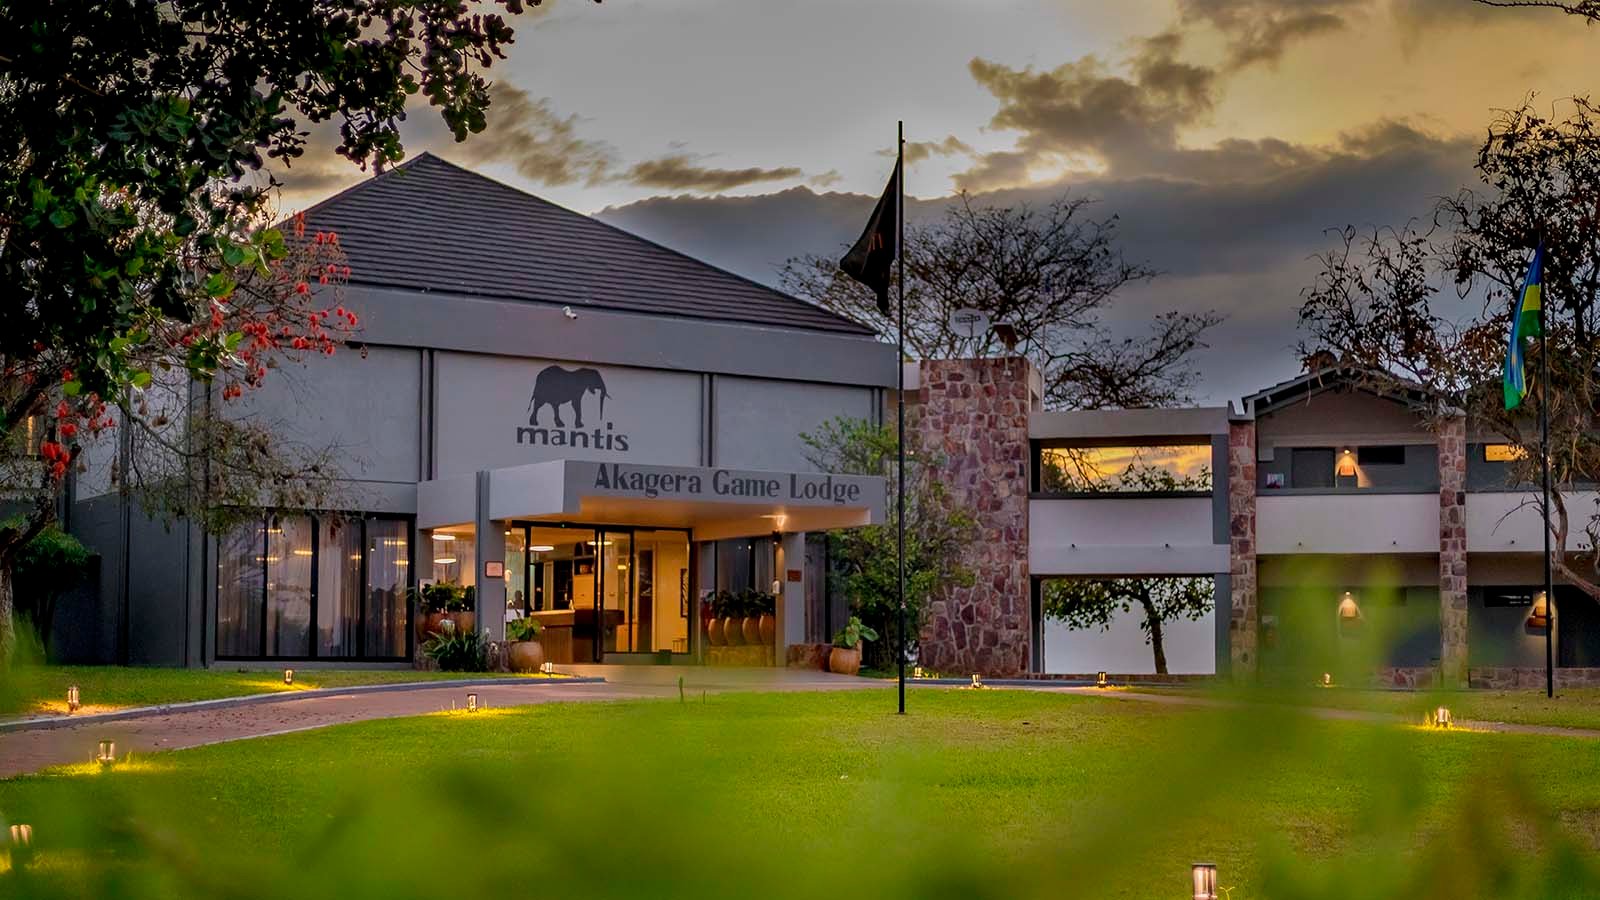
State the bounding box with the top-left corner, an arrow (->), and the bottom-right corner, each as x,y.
0,666 -> 882,778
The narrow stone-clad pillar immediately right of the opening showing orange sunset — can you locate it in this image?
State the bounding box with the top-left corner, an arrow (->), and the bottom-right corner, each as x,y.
1227,421 -> 1261,679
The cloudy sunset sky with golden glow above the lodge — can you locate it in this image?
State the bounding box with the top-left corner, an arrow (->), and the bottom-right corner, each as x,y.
278,0 -> 1600,404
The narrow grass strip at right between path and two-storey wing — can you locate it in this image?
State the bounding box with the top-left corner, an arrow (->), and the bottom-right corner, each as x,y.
1133,685 -> 1600,730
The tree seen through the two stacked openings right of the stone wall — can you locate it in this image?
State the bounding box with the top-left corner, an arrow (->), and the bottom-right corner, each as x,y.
1040,453 -> 1214,674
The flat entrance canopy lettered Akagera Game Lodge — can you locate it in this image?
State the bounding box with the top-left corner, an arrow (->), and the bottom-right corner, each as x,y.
418,460 -> 888,540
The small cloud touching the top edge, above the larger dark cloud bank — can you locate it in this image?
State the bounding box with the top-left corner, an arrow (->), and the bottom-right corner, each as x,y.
1178,0 -> 1363,69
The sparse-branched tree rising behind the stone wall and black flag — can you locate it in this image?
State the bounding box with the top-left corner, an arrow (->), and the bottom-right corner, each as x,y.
779,194 -> 1221,408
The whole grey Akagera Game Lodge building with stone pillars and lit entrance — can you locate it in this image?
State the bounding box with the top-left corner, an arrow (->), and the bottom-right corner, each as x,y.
53,154 -> 1600,684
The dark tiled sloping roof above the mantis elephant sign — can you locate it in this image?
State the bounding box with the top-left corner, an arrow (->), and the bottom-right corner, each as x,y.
306,154 -> 874,335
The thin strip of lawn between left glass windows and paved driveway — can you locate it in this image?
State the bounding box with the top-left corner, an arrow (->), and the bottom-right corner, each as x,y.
0,666 -> 541,716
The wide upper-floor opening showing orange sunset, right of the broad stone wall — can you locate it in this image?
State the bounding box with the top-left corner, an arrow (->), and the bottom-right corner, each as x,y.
1038,444 -> 1211,493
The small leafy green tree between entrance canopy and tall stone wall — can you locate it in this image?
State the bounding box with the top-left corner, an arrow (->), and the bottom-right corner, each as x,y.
800,416 -> 978,666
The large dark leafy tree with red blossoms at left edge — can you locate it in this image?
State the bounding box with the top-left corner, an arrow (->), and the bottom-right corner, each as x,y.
0,0 -> 588,666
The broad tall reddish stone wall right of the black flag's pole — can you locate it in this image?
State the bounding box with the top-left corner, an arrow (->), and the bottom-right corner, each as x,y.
915,359 -> 1034,677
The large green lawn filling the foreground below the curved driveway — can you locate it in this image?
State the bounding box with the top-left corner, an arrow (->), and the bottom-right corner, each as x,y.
0,689 -> 1600,900
